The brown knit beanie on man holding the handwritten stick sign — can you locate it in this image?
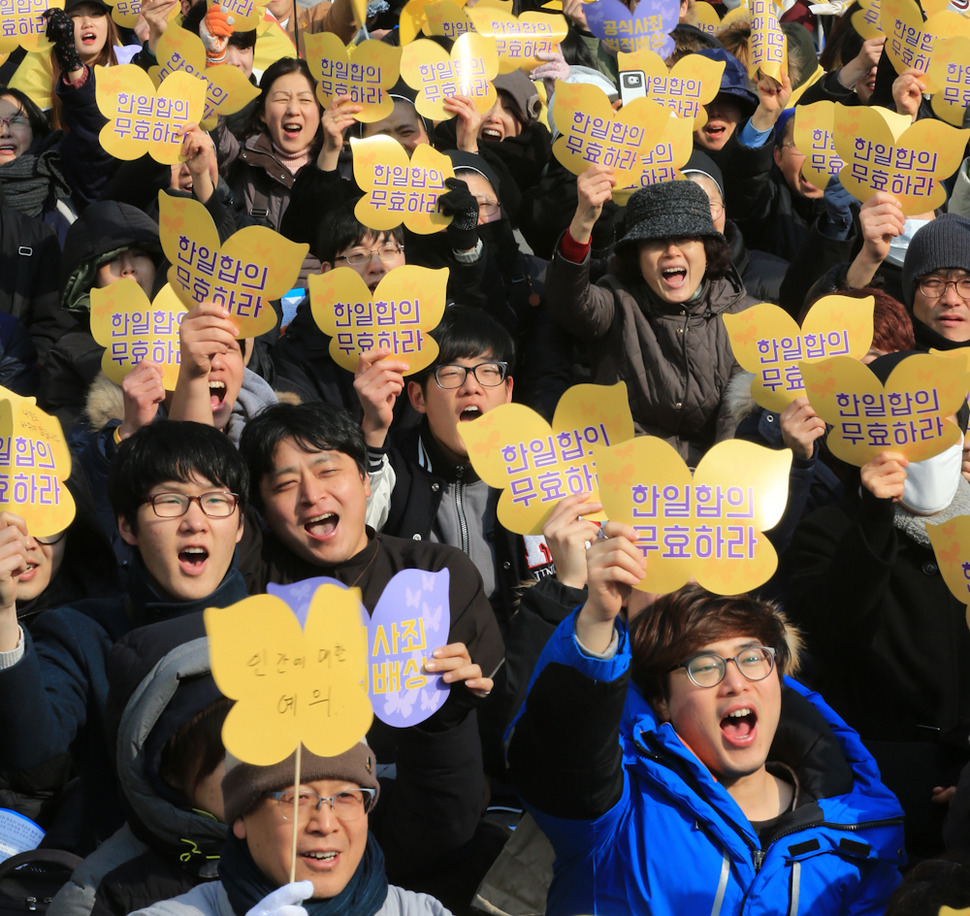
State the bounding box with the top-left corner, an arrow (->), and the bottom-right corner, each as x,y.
222,739 -> 381,825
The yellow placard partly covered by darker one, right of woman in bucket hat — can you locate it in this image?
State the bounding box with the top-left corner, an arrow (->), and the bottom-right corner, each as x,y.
723,296 -> 875,413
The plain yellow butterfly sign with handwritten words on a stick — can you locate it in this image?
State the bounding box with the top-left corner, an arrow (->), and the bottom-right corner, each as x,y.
205,584 -> 374,766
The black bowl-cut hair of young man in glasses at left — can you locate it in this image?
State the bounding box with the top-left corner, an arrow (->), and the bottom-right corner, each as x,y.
108,420 -> 249,533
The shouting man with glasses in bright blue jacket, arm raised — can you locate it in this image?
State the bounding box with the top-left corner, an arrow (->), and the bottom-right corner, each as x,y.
508,522 -> 905,916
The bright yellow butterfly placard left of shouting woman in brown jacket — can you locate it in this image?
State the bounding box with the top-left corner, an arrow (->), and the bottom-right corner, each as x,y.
94,64 -> 206,165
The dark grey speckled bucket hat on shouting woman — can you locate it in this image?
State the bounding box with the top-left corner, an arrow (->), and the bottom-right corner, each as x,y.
616,181 -> 724,252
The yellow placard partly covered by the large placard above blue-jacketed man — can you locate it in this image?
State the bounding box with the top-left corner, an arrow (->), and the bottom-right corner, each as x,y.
458,382 -> 633,534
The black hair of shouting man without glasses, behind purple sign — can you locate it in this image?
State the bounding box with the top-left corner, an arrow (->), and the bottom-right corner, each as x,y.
239,401 -> 367,508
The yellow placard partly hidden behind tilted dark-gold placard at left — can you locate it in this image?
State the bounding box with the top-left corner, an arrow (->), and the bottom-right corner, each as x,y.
91,277 -> 188,391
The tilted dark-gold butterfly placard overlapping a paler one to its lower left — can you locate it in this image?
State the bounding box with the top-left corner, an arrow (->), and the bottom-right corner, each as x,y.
158,191 -> 310,337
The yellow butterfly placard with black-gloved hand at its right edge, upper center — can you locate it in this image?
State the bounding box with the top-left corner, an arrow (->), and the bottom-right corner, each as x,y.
350,136 -> 455,235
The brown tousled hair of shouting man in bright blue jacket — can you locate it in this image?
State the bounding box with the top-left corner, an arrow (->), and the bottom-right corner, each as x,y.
630,585 -> 801,708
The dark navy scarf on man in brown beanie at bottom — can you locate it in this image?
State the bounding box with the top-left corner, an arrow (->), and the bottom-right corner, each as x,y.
219,833 -> 387,916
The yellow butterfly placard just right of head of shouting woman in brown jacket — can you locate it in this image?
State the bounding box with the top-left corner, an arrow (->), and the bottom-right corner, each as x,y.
303,32 -> 401,123
